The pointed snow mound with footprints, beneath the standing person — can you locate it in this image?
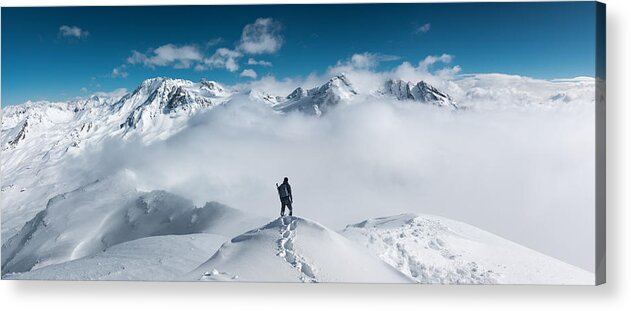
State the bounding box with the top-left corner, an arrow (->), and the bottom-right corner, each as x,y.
187,216 -> 413,283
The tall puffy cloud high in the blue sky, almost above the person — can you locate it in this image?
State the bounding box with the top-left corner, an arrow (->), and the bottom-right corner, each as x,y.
237,18 -> 283,54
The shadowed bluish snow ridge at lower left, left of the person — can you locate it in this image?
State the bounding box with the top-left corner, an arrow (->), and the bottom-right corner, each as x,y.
2,175 -> 263,275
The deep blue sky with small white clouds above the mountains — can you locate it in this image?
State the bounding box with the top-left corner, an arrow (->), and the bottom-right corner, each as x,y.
2,2 -> 596,105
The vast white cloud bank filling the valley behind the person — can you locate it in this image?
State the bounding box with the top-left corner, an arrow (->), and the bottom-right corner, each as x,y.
79,73 -> 595,267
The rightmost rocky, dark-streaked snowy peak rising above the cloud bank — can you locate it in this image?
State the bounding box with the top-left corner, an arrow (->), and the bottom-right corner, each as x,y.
380,79 -> 458,109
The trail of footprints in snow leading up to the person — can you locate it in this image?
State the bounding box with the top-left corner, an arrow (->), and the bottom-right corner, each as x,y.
277,216 -> 318,283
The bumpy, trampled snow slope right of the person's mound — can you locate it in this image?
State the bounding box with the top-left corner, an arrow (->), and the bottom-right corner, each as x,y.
340,214 -> 594,284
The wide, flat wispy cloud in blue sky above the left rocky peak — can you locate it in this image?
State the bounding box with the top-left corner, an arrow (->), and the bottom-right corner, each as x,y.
127,44 -> 203,69
